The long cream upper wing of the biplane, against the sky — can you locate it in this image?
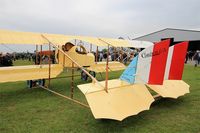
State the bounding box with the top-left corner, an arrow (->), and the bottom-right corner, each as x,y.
0,30 -> 153,48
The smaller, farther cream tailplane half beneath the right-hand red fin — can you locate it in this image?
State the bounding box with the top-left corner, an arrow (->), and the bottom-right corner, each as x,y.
148,80 -> 190,98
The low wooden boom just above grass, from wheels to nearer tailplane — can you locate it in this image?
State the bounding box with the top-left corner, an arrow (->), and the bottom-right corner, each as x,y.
39,85 -> 90,108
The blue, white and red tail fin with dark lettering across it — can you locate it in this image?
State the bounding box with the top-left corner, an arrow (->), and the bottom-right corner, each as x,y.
120,40 -> 170,84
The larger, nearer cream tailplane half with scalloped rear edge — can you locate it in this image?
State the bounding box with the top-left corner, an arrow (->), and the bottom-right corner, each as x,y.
78,79 -> 154,121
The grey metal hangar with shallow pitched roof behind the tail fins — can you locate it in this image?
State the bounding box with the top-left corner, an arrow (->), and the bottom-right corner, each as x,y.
133,28 -> 200,51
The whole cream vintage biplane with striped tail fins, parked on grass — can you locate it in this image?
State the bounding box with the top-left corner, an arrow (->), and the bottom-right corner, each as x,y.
0,30 -> 189,121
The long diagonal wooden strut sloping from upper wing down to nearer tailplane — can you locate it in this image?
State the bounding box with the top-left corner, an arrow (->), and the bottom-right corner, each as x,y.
41,35 -> 104,88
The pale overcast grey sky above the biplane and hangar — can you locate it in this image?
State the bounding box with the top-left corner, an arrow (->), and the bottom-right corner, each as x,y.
0,0 -> 200,51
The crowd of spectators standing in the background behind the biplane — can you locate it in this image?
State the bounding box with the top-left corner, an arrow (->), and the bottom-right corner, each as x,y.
0,48 -> 200,67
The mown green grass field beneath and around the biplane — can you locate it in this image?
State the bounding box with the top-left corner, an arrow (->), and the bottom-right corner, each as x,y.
0,60 -> 200,133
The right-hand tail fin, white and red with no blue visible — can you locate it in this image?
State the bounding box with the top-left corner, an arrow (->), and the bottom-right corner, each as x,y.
164,42 -> 188,80
